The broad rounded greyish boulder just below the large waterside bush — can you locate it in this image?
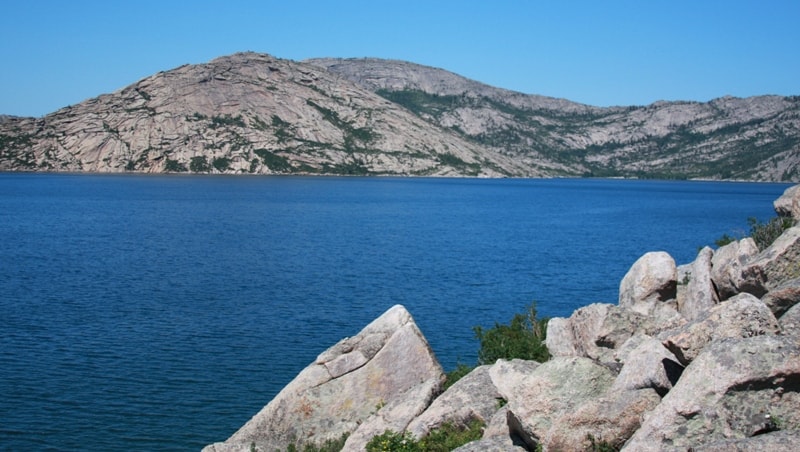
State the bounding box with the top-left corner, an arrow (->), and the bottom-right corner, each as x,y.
508,357 -> 614,450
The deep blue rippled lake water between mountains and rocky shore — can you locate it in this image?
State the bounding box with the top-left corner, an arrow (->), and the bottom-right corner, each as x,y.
0,174 -> 788,450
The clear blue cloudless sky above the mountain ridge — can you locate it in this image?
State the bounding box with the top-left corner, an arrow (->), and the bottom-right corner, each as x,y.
0,0 -> 800,116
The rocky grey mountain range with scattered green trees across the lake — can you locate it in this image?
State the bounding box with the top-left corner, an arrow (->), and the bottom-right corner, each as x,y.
0,53 -> 800,181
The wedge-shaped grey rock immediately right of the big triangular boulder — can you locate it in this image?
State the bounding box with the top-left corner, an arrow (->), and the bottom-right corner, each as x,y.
406,366 -> 501,438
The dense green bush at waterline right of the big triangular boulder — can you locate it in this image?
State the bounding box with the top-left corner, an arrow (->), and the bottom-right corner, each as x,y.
474,303 -> 550,364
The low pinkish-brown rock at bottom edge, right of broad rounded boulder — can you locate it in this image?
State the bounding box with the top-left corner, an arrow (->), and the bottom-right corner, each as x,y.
542,389 -> 661,451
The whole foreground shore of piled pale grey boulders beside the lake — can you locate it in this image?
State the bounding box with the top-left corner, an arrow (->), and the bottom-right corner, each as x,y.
204,186 -> 800,452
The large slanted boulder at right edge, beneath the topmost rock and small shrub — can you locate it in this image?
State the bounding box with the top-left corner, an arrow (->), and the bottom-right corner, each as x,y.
740,226 -> 800,298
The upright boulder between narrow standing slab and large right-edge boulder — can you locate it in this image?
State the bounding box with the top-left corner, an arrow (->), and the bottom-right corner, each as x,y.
712,237 -> 758,301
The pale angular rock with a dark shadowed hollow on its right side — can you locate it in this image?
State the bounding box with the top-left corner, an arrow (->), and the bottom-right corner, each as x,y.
611,337 -> 683,397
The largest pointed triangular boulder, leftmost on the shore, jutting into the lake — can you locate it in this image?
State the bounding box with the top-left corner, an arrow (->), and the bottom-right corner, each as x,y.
204,305 -> 444,452
